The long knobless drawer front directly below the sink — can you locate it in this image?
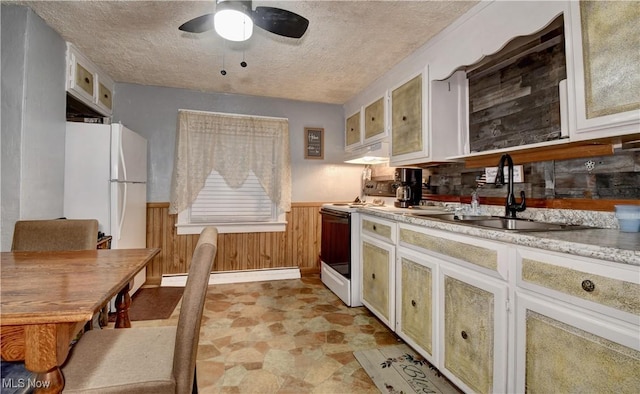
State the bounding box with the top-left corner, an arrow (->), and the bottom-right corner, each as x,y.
398,226 -> 507,279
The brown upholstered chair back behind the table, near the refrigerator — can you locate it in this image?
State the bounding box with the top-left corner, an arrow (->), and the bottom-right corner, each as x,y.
11,219 -> 98,251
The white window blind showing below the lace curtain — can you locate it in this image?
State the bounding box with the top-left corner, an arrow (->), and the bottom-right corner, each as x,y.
190,170 -> 277,223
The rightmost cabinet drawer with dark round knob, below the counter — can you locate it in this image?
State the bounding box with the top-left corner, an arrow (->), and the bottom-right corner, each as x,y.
517,248 -> 640,324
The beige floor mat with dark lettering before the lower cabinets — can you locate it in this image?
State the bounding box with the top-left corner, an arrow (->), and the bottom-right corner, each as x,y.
353,344 -> 462,394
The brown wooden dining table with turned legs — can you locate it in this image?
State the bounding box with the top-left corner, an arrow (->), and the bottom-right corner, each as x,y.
0,248 -> 160,393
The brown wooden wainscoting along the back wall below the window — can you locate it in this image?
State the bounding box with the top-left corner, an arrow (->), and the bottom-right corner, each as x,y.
146,202 -> 322,285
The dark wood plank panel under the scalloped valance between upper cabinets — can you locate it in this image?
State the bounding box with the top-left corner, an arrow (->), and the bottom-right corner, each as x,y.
467,22 -> 566,152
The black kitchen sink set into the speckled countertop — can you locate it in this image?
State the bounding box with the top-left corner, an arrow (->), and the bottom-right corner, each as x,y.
407,212 -> 594,232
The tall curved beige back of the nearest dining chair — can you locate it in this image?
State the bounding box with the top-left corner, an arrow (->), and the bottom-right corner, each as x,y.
173,227 -> 218,393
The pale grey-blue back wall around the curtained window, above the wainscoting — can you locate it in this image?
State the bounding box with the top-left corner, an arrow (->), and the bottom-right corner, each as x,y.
113,83 -> 362,202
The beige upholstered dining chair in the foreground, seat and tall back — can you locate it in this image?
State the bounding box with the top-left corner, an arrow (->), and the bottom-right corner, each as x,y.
62,227 -> 218,394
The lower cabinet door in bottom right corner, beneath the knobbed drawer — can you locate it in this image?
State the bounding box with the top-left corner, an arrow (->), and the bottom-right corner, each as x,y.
516,293 -> 640,393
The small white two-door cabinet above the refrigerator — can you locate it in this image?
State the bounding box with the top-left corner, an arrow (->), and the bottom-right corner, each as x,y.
65,43 -> 114,116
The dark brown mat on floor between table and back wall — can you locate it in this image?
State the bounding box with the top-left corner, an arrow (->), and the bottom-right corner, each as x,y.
109,287 -> 184,322
